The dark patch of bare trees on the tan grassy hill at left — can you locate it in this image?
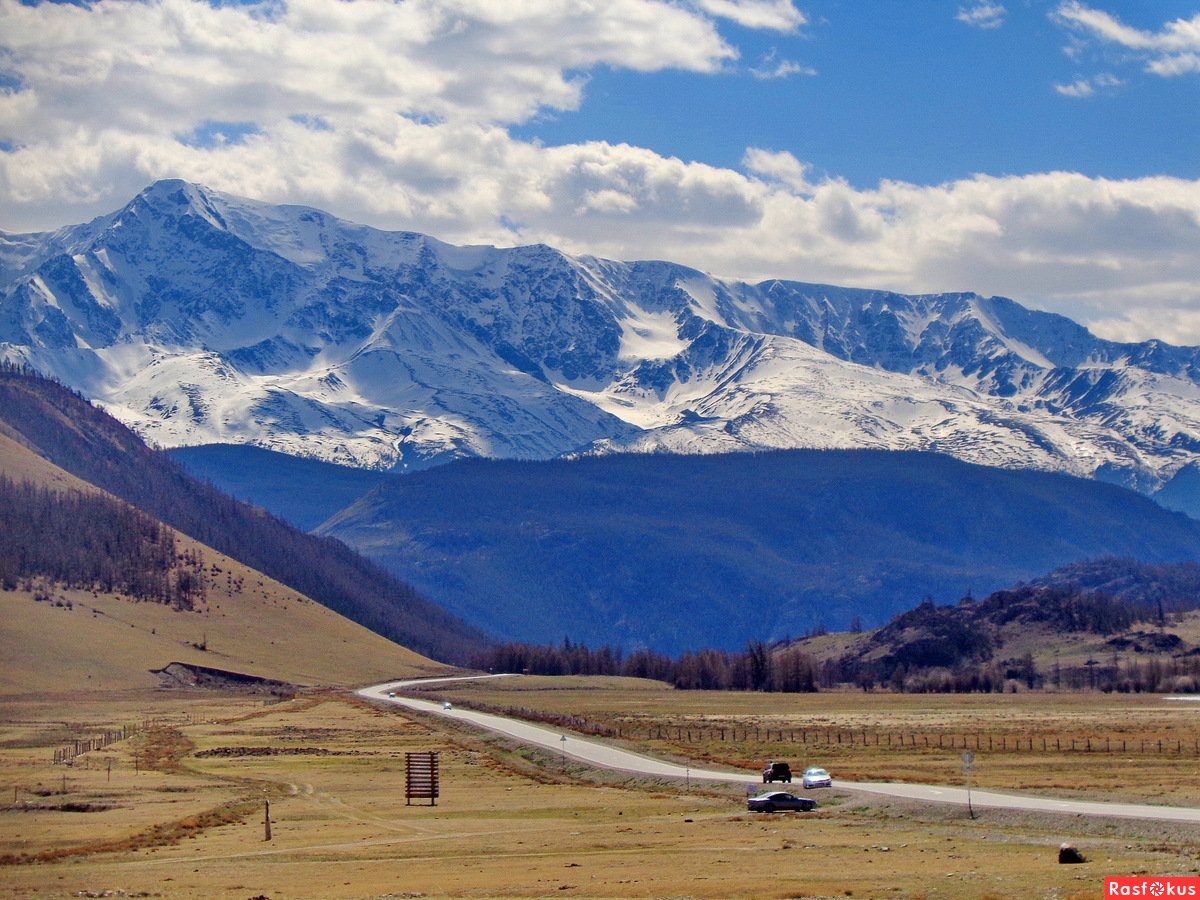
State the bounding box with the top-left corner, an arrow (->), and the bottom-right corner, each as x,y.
0,475 -> 205,610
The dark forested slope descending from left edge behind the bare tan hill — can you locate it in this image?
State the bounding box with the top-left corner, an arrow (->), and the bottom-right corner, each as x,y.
0,368 -> 487,661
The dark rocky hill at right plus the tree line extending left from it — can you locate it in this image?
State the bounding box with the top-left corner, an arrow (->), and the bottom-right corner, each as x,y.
473,558 -> 1200,692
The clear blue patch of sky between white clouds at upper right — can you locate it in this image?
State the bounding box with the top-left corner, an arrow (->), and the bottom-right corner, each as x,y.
517,0 -> 1200,187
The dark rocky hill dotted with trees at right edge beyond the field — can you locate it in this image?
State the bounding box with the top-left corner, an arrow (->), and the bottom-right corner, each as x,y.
816,557 -> 1200,691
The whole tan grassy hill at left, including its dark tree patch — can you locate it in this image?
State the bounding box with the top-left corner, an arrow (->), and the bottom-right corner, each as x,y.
0,427 -> 454,698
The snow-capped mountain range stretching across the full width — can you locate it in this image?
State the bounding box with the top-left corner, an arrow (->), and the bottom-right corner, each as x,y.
0,181 -> 1200,491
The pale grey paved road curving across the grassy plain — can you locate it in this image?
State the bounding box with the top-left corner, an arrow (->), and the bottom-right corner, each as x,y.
358,676 -> 1200,823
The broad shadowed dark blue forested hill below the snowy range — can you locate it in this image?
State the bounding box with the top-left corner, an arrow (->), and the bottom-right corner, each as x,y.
322,450 -> 1200,653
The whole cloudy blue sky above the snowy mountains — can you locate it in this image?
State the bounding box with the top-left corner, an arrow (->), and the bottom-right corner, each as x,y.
0,0 -> 1200,344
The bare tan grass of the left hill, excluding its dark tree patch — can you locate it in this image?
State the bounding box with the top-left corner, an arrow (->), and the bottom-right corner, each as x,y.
0,412 -> 446,696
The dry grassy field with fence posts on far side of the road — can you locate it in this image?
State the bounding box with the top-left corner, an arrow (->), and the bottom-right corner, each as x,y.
438,677 -> 1200,806
